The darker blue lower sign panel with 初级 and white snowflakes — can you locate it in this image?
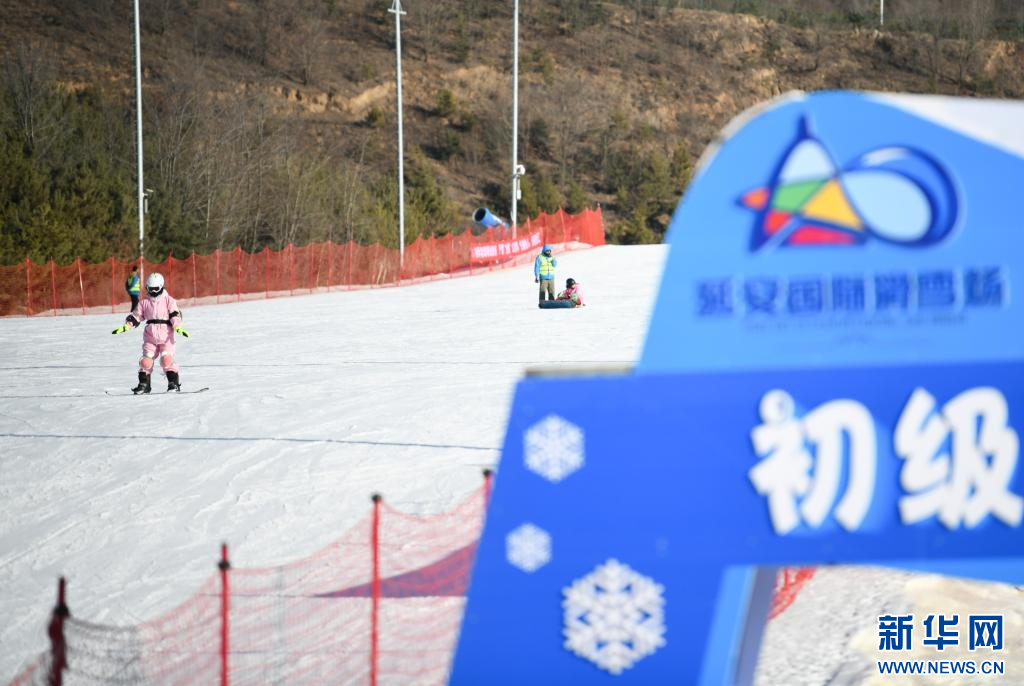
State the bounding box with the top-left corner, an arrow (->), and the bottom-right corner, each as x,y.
454,363 -> 1024,684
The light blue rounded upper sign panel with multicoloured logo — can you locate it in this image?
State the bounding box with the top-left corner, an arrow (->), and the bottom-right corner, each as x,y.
639,93 -> 1024,372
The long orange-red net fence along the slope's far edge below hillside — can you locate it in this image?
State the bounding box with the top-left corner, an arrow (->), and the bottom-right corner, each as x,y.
0,209 -> 604,316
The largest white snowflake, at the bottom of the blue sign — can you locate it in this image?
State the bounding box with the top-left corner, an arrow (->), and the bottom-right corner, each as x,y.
562,559 -> 666,675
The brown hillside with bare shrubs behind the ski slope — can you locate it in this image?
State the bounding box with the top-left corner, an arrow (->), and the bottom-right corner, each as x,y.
0,0 -> 1024,258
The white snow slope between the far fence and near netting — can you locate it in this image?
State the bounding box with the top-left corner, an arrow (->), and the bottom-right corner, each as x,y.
0,246 -> 668,682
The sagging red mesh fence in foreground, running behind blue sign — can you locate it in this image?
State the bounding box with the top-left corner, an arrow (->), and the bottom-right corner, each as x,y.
4,472 -> 813,686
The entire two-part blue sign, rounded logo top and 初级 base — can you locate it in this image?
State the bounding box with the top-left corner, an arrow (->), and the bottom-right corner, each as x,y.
452,93 -> 1024,684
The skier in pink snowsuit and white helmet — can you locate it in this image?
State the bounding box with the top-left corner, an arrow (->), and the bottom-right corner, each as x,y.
111,272 -> 188,394
